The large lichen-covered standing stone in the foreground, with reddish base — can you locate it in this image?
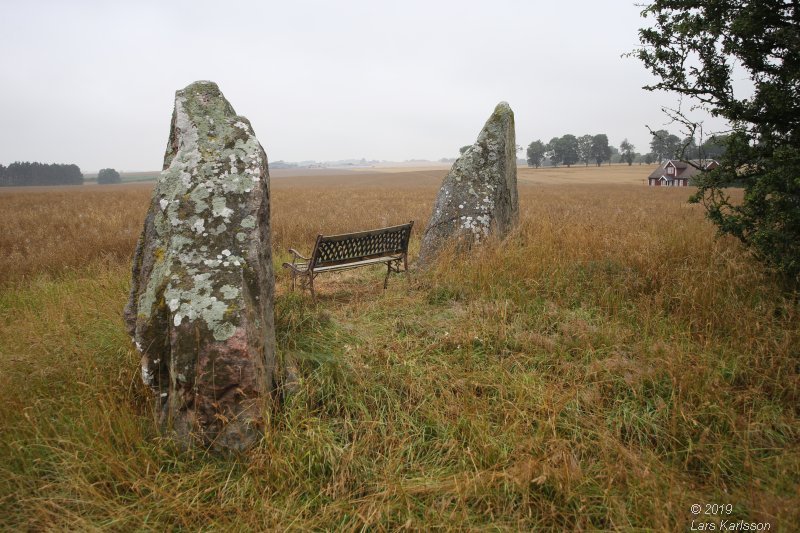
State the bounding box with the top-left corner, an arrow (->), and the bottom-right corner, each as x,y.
125,81 -> 276,451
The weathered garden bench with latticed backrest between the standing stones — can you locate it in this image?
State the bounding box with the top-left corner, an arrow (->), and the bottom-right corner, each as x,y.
283,221 -> 414,301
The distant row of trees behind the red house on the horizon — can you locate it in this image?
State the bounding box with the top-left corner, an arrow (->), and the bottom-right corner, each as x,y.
526,130 -> 727,168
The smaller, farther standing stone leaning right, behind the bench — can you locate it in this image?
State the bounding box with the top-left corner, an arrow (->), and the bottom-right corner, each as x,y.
417,102 -> 519,268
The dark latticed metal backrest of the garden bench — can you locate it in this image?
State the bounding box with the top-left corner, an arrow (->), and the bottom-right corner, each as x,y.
309,221 -> 414,269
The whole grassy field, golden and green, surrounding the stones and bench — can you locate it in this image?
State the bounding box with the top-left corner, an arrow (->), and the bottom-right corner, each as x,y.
0,165 -> 800,531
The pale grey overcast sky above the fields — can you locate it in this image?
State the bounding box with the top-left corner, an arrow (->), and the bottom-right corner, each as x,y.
0,0 -> 728,172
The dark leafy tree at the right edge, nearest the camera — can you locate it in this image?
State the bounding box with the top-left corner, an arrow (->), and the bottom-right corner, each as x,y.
633,0 -> 800,285
